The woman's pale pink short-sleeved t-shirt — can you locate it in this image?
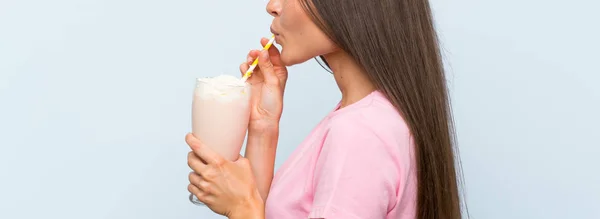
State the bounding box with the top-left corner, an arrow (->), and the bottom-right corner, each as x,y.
266,91 -> 417,219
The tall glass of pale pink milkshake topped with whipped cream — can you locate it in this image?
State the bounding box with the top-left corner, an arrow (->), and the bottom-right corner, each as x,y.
189,75 -> 250,205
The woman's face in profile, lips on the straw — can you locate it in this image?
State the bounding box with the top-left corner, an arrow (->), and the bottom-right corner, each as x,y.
267,0 -> 336,66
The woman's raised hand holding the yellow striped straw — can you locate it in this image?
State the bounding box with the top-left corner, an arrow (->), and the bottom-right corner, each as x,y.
240,38 -> 288,132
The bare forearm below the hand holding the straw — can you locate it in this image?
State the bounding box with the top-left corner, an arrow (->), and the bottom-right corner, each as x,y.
245,124 -> 279,201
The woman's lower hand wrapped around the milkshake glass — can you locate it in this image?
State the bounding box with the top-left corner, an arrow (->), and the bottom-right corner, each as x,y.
185,134 -> 264,218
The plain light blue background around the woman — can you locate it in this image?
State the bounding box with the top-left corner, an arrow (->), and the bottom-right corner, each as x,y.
0,0 -> 600,219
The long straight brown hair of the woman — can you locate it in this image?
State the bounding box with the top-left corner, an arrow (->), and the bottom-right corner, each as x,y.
300,0 -> 461,219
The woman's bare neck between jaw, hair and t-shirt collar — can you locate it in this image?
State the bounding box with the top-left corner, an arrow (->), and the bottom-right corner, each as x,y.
324,51 -> 375,108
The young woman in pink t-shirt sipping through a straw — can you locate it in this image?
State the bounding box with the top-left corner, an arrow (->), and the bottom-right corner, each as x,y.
186,0 -> 461,219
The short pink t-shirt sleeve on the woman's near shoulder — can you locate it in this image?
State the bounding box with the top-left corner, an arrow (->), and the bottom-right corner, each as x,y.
309,121 -> 400,219
